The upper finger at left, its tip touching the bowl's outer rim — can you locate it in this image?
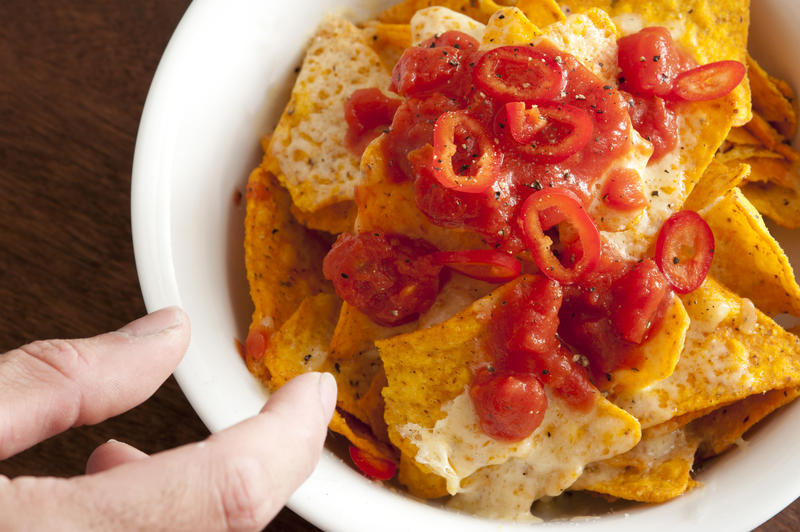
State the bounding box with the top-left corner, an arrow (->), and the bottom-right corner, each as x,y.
0,307 -> 189,460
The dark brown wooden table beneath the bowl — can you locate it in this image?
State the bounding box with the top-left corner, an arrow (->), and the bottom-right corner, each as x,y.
0,0 -> 800,531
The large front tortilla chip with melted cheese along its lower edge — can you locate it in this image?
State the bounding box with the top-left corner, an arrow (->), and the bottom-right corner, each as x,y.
376,276 -> 640,513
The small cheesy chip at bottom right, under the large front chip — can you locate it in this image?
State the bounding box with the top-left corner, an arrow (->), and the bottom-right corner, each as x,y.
570,430 -> 698,503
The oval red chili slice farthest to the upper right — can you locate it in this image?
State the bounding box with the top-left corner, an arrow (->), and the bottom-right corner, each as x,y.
671,61 -> 747,102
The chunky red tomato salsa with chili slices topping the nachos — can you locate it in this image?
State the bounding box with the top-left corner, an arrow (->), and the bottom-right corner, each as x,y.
323,27 -> 732,442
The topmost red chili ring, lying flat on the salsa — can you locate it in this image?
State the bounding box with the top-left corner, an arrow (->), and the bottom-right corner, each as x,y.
472,46 -> 567,102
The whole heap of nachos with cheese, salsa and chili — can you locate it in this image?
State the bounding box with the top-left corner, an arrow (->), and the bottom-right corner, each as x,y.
241,1 -> 800,519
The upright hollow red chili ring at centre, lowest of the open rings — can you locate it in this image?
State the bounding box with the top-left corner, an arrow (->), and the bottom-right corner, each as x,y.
519,187 -> 600,284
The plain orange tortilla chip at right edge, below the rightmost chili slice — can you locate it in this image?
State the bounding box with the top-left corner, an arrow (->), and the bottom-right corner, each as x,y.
701,188 -> 800,315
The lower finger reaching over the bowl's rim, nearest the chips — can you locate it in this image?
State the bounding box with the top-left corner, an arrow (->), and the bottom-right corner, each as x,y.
0,373 -> 336,530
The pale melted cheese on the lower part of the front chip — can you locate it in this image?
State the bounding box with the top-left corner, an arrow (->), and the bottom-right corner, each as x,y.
399,388 -> 640,520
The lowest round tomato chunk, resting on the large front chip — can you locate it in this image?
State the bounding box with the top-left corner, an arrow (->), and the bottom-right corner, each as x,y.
469,369 -> 547,441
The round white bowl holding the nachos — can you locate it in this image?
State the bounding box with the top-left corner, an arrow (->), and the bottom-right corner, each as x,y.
132,0 -> 800,532
